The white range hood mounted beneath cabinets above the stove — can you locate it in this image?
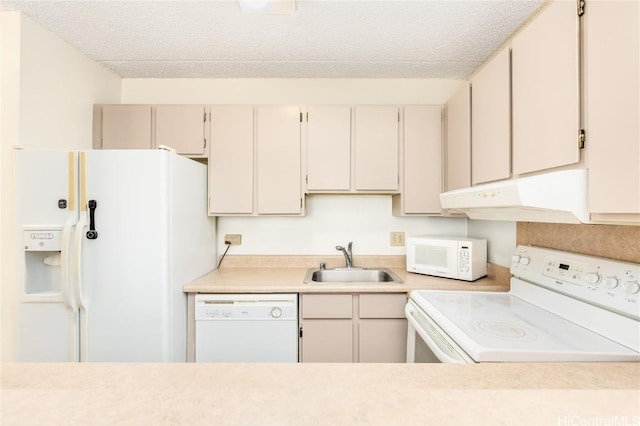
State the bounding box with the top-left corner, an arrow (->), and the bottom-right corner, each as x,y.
440,169 -> 589,223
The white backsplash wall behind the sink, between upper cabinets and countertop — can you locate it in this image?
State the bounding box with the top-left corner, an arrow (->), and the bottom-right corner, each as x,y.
218,195 -> 466,255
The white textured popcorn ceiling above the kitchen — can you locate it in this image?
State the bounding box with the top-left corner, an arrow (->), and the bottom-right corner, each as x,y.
0,0 -> 543,78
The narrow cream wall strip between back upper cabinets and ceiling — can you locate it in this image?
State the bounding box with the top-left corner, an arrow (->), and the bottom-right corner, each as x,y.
122,78 -> 463,105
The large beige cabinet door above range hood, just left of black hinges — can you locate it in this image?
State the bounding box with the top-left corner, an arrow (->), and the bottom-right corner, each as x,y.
512,1 -> 580,174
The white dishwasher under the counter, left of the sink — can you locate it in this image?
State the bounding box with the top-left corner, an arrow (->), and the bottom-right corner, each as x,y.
195,294 -> 298,362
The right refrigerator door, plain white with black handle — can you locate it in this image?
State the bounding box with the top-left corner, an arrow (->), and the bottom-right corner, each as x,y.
75,150 -> 171,362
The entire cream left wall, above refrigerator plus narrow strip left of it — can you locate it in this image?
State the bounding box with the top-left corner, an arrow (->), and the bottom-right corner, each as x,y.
0,12 -> 120,361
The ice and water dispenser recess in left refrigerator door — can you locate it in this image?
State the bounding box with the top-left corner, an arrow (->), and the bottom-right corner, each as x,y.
23,228 -> 62,295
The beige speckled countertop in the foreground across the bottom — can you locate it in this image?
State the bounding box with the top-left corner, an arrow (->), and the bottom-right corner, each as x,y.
0,363 -> 640,426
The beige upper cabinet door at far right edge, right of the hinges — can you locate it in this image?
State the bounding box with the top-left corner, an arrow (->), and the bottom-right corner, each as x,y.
585,1 -> 640,221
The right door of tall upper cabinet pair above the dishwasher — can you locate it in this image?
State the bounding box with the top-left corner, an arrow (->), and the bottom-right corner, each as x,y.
256,106 -> 302,214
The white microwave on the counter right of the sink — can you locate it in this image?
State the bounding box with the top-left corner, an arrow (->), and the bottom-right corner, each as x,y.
407,235 -> 487,281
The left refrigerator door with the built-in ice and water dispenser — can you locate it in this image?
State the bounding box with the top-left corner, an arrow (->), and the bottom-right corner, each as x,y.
15,150 -> 79,362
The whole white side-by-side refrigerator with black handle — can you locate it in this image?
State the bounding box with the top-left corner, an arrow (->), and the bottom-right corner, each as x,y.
15,149 -> 215,362
